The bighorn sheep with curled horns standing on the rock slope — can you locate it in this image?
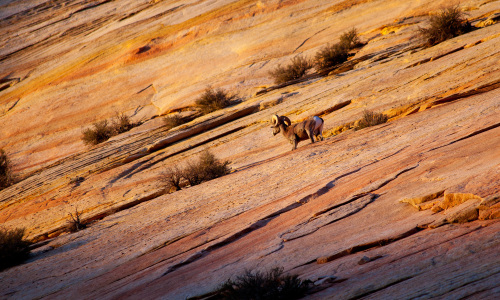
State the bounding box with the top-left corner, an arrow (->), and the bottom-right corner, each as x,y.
271,115 -> 324,150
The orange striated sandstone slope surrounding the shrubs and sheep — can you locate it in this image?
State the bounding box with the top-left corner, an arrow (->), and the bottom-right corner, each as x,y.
0,0 -> 500,299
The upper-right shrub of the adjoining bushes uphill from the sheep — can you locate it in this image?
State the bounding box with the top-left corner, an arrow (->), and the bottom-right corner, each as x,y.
314,28 -> 361,72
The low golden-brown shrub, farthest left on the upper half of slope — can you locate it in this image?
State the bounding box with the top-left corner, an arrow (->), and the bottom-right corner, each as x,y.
82,114 -> 139,146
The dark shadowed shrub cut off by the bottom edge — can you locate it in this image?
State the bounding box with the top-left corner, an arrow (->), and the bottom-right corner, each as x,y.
219,268 -> 309,300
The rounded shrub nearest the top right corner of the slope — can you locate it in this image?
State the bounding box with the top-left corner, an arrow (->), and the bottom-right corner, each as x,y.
420,5 -> 472,46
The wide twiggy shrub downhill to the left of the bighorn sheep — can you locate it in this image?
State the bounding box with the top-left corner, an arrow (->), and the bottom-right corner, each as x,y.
163,150 -> 231,190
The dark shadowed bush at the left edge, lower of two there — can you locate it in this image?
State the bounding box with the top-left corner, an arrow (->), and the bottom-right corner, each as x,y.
0,228 -> 31,270
